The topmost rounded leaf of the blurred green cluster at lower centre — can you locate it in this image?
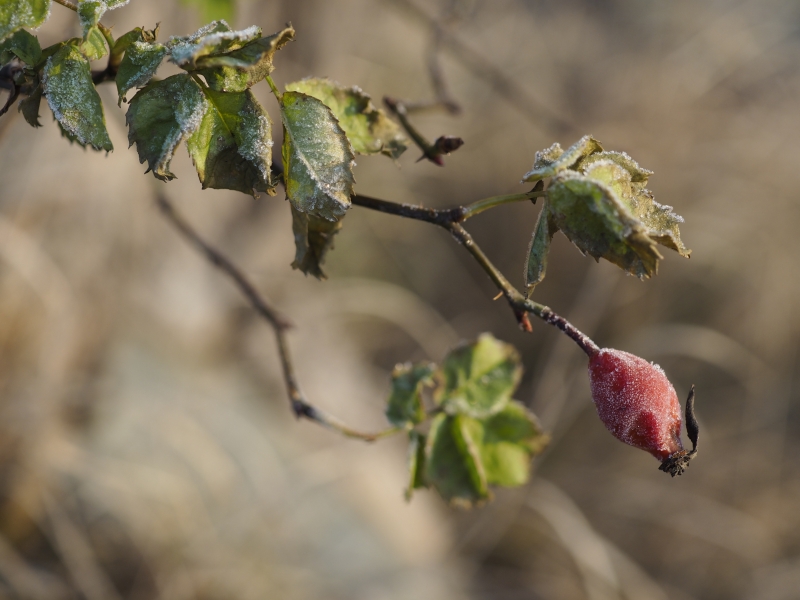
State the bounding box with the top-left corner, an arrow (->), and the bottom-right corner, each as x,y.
434,333 -> 522,418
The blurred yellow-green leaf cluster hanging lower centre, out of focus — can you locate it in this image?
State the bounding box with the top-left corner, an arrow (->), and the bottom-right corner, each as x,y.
386,333 -> 548,507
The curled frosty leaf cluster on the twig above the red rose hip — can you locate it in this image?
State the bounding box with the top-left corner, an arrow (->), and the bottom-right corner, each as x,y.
523,136 -> 691,288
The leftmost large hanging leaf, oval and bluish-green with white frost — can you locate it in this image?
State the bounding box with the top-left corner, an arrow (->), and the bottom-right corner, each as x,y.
42,45 -> 114,152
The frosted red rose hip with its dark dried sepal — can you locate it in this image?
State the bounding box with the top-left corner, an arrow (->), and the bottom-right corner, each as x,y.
589,348 -> 699,477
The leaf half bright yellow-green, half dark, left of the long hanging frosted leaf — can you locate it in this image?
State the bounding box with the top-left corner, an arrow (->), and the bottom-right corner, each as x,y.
186,88 -> 274,196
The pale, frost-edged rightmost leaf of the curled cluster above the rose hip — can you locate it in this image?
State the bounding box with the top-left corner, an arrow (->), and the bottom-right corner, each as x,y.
583,159 -> 691,257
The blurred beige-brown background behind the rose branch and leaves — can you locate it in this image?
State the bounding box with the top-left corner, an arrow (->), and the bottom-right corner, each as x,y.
0,0 -> 800,600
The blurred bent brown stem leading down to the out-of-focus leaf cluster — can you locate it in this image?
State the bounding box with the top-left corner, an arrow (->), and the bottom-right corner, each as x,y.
156,196 -> 404,442
